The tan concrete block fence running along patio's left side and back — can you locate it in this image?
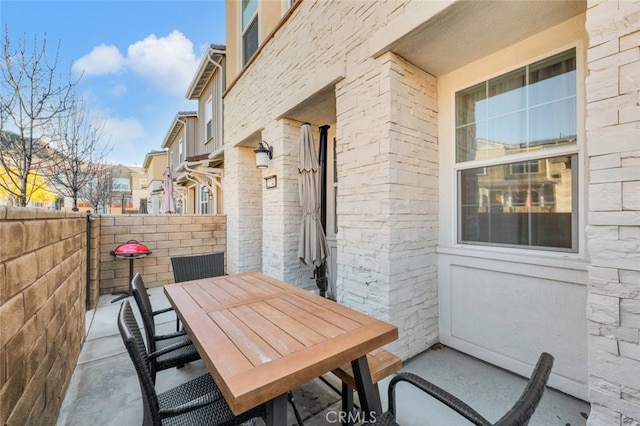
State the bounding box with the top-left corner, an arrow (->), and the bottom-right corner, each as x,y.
0,210 -> 226,426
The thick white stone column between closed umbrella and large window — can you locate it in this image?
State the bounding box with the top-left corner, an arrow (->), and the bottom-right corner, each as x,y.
336,53 -> 438,358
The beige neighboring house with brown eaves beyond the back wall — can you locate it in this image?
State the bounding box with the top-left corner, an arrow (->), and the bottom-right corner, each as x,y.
162,44 -> 225,214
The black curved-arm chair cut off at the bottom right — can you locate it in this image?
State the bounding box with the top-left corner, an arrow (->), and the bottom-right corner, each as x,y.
372,352 -> 553,426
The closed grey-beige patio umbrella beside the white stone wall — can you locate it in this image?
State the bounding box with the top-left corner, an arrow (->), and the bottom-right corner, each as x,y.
298,123 -> 329,267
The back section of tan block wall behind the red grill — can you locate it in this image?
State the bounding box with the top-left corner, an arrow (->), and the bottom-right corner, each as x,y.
99,214 -> 226,294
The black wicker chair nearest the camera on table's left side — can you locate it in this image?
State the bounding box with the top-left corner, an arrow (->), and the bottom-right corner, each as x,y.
118,300 -> 266,426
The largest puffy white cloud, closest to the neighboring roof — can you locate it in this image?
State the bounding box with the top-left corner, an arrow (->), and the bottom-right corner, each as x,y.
127,30 -> 199,96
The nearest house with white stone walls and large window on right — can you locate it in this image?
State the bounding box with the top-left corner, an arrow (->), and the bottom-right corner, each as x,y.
223,0 -> 640,424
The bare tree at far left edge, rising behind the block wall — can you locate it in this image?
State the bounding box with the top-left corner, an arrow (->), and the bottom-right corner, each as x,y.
0,26 -> 77,206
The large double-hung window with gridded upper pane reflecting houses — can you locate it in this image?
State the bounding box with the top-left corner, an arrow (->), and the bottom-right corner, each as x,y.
455,49 -> 578,252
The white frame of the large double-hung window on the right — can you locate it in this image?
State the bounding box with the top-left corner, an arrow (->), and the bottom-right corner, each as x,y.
450,47 -> 585,255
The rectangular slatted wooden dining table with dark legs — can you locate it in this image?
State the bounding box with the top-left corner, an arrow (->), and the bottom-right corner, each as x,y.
164,272 -> 398,425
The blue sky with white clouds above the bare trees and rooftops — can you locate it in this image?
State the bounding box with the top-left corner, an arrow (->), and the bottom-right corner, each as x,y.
0,0 -> 225,166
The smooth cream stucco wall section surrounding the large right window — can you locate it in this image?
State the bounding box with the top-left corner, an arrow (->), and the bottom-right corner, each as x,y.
438,14 -> 588,399
